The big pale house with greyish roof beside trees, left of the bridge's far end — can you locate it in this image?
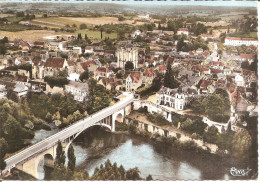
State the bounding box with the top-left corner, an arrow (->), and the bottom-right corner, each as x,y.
65,81 -> 89,102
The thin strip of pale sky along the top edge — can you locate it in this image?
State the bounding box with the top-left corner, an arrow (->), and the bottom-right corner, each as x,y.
0,0 -> 257,7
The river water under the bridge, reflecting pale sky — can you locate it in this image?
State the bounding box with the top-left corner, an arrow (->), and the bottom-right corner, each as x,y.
33,127 -> 250,180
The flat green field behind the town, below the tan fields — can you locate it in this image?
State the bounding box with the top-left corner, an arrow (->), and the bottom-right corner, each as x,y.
75,30 -> 117,39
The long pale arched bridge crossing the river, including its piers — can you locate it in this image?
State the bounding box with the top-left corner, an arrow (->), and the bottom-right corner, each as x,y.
3,93 -> 134,179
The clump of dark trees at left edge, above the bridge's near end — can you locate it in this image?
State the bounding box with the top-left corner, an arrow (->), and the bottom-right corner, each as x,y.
0,99 -> 35,156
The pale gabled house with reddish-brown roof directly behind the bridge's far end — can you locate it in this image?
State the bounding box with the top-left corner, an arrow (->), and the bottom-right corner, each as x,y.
124,71 -> 143,92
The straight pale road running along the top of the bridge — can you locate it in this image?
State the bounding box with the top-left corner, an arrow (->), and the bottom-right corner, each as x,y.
3,94 -> 134,174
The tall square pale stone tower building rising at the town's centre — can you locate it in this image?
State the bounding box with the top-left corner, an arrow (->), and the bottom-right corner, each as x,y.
116,44 -> 139,69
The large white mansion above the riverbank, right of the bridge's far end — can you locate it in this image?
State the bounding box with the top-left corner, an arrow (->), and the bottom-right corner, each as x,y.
156,87 -> 197,110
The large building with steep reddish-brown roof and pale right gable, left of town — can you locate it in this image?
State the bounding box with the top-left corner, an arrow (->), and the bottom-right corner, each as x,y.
43,58 -> 69,77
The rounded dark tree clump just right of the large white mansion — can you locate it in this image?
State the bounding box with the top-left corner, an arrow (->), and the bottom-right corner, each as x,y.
191,89 -> 230,123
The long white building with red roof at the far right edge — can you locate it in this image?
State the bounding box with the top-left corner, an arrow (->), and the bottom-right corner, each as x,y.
224,37 -> 258,46
